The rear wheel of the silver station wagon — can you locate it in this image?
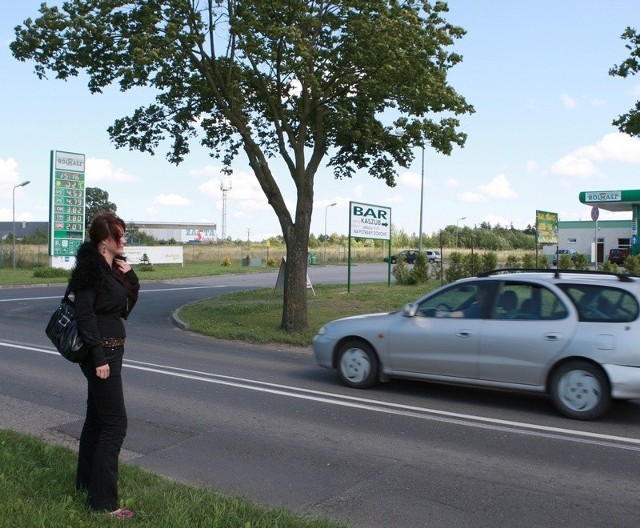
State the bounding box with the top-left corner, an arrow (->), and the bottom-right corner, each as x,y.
550,361 -> 611,420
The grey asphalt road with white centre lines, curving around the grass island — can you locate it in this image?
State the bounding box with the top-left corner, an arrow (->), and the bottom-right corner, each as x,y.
0,265 -> 640,528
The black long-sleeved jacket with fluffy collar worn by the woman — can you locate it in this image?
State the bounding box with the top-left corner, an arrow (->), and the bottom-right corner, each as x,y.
70,242 -> 140,367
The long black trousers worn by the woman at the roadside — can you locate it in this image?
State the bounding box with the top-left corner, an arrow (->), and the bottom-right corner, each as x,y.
76,347 -> 127,511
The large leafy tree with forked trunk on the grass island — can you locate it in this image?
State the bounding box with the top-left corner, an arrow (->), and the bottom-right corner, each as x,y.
11,0 -> 473,331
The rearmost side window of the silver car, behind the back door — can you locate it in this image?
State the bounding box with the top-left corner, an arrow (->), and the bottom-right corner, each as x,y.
560,284 -> 640,323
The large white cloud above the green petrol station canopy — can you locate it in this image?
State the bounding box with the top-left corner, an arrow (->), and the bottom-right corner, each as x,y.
551,132 -> 640,178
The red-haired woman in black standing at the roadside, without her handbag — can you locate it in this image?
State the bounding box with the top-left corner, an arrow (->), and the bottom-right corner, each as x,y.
71,212 -> 140,519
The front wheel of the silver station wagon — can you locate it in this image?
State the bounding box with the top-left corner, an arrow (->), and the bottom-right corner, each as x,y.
338,339 -> 378,389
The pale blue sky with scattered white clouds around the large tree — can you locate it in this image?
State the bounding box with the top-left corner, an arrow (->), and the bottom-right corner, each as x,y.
0,0 -> 640,241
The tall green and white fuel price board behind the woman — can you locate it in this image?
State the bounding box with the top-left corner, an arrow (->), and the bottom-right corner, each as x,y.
49,151 -> 86,257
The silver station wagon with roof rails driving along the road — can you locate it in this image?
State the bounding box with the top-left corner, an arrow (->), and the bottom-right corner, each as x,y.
313,270 -> 640,420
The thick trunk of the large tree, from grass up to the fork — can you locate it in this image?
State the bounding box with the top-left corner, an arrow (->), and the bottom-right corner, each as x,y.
281,211 -> 311,332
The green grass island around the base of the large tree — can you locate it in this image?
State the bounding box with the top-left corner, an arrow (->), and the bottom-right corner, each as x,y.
179,280 -> 440,346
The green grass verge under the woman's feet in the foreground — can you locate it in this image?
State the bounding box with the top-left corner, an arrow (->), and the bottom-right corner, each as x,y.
0,429 -> 347,528
